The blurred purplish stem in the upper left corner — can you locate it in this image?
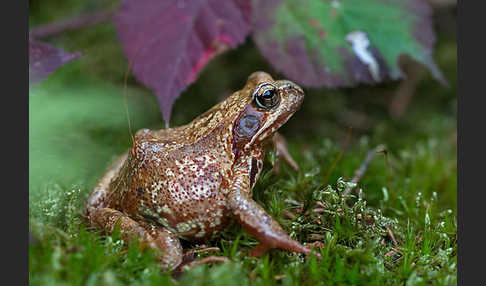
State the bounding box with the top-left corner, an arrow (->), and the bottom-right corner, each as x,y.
29,9 -> 115,39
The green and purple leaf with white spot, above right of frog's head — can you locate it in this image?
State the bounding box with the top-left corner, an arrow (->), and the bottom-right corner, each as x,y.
253,0 -> 445,87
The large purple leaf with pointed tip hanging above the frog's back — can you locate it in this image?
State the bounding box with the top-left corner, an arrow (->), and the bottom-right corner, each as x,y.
115,0 -> 251,123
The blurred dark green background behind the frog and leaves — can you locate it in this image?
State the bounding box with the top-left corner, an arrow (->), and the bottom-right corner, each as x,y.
29,0 -> 457,193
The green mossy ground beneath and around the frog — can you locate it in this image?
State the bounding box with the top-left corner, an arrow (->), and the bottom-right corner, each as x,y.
30,124 -> 457,285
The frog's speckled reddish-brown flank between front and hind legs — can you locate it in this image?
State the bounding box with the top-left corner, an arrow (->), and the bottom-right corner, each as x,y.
112,122 -> 236,239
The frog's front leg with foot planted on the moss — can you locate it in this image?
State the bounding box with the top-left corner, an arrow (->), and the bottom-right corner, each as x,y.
228,190 -> 318,256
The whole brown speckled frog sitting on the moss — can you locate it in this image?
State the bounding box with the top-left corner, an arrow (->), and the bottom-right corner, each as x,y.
84,71 -> 311,269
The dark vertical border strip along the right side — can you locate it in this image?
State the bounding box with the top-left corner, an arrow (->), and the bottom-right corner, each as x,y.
457,0 -> 486,285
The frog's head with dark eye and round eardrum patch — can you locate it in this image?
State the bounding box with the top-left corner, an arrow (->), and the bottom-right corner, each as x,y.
233,72 -> 304,149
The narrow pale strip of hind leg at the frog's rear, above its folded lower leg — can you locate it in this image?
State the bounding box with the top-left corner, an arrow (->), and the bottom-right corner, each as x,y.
83,152 -> 128,217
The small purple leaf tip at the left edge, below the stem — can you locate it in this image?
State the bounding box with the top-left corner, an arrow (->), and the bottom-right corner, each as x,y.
29,39 -> 81,85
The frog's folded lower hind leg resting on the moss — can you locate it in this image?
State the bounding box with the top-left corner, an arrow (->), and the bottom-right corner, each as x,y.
89,208 -> 183,270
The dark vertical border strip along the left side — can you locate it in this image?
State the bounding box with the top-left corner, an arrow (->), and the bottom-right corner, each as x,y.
0,1 -> 29,285
